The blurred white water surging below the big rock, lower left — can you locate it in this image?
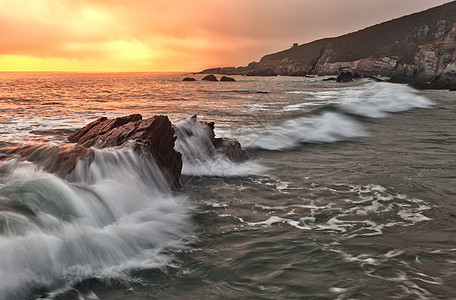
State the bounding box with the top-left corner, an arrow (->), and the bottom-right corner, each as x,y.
0,149 -> 193,299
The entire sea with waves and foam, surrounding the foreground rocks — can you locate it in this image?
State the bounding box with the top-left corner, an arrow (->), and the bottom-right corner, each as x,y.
0,73 -> 456,299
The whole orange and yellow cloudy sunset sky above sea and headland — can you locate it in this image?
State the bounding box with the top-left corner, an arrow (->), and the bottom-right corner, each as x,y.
0,0 -> 450,72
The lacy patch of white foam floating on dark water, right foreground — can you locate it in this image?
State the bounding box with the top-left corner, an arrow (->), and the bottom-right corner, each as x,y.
245,184 -> 431,238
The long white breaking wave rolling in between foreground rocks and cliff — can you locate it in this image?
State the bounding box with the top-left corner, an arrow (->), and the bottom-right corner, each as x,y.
230,82 -> 433,150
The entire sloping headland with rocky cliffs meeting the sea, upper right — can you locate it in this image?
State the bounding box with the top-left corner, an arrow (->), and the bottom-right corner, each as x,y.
201,1 -> 456,88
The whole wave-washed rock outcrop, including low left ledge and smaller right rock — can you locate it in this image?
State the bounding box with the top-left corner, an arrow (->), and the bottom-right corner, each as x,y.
1,114 -> 248,188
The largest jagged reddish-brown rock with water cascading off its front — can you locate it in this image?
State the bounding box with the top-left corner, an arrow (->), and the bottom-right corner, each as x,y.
68,114 -> 182,186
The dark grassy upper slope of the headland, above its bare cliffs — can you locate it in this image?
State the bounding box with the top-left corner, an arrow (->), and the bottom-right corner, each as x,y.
260,1 -> 456,64
